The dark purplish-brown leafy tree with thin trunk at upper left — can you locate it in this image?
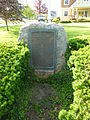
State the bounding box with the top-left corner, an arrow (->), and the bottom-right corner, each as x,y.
0,0 -> 22,31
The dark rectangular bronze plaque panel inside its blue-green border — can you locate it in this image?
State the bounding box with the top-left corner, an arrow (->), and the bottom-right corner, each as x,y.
31,31 -> 55,69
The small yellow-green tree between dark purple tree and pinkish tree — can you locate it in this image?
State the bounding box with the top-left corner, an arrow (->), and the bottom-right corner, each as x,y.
22,5 -> 35,19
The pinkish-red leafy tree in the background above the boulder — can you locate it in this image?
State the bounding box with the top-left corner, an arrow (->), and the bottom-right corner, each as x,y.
34,0 -> 48,15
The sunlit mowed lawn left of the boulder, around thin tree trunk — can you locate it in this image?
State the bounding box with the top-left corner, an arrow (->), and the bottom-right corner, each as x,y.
0,25 -> 20,42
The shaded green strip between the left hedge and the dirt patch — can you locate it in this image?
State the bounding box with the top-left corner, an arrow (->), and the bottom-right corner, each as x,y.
7,68 -> 33,120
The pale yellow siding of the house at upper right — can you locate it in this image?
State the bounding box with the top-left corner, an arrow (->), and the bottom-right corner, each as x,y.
61,0 -> 90,21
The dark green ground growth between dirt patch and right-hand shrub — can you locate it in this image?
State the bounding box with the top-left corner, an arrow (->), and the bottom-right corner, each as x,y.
38,65 -> 73,120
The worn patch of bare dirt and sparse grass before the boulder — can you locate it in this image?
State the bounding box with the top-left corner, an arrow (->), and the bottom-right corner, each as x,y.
29,83 -> 56,120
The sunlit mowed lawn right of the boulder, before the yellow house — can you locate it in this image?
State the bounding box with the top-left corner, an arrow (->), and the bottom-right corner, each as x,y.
62,23 -> 90,39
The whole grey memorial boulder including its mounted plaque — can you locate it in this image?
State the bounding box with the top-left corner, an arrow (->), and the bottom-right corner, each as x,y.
18,22 -> 67,76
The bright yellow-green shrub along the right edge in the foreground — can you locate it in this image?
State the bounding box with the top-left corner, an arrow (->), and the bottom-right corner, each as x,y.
59,45 -> 90,120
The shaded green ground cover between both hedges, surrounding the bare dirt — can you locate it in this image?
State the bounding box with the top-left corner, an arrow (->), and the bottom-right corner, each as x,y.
4,66 -> 73,120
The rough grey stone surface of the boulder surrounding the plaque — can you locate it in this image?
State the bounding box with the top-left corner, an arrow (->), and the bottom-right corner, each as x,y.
18,22 -> 67,76
